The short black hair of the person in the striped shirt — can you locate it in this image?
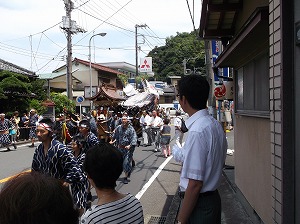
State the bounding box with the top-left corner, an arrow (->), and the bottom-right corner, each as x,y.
83,142 -> 123,189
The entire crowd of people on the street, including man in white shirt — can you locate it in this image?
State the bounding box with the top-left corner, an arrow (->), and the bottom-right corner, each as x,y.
0,75 -> 227,224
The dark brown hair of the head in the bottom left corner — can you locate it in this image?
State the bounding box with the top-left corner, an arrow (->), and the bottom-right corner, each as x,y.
0,171 -> 79,224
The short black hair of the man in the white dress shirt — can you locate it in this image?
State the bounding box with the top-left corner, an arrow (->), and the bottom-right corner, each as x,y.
178,75 -> 210,110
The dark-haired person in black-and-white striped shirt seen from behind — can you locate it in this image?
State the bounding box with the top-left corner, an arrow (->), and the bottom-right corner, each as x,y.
82,143 -> 144,224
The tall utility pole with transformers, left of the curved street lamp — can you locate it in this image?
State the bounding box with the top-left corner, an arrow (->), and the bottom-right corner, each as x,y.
61,0 -> 86,100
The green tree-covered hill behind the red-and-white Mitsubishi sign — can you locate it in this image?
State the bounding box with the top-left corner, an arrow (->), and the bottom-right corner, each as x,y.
148,31 -> 205,81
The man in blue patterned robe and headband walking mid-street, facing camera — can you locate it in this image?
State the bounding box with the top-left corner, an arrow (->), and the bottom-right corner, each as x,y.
110,116 -> 137,184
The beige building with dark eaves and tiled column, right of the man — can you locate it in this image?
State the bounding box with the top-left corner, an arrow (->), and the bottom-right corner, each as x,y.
199,0 -> 300,223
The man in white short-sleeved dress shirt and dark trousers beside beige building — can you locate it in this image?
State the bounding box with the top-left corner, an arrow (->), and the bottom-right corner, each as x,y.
177,75 -> 227,224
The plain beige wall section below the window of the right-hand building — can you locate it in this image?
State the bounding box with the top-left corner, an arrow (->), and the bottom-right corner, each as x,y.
234,115 -> 273,223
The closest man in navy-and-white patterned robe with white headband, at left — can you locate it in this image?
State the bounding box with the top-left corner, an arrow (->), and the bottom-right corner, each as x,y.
31,118 -> 87,212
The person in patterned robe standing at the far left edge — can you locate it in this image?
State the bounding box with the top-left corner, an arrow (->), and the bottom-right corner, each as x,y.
0,113 -> 17,151
